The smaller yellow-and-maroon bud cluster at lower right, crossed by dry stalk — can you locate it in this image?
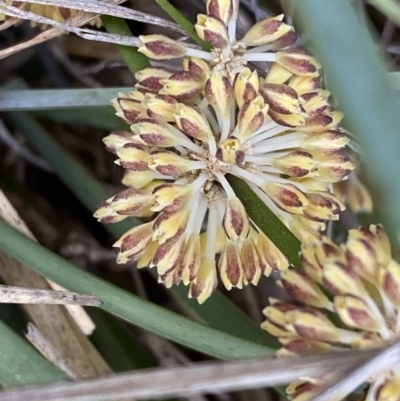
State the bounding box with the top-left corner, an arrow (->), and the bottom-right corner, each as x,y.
262,225 -> 400,401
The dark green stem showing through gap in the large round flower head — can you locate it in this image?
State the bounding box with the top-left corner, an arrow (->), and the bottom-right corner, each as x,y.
229,175 -> 301,267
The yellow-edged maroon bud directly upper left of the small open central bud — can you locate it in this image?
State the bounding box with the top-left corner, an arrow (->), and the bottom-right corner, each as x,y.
175,103 -> 213,142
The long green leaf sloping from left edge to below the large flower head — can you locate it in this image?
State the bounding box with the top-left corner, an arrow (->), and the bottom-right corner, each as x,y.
0,220 -> 273,359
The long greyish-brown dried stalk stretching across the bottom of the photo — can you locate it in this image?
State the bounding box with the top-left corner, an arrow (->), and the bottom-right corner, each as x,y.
0,343 -> 400,401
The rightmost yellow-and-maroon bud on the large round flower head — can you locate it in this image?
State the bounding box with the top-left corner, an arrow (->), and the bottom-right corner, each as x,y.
316,152 -> 355,183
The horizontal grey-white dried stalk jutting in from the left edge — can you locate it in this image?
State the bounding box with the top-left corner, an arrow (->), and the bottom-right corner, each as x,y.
0,285 -> 102,306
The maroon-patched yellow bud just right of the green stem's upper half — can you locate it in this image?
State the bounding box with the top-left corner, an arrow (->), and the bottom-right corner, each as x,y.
263,181 -> 309,214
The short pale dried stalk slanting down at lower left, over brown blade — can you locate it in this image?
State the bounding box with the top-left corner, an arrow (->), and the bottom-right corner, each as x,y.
25,323 -> 80,380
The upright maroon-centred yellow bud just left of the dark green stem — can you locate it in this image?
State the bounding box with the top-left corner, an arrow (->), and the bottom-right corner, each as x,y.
223,197 -> 250,241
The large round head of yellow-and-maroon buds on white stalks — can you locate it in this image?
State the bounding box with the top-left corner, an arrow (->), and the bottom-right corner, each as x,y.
95,0 -> 353,302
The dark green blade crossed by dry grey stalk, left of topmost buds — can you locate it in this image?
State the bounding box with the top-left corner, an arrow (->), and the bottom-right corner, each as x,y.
101,15 -> 150,75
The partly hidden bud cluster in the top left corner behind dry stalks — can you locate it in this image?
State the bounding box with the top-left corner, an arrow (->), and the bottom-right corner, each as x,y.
0,0 -> 101,30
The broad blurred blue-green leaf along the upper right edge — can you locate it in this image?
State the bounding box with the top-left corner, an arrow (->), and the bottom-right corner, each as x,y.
284,0 -> 400,240
